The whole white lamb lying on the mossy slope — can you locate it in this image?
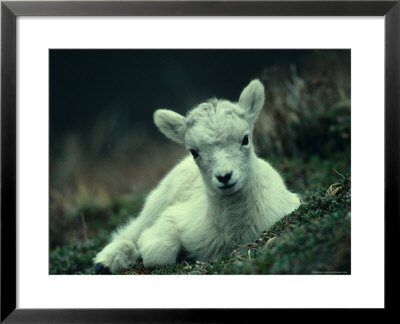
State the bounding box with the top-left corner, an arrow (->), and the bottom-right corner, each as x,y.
94,80 -> 300,273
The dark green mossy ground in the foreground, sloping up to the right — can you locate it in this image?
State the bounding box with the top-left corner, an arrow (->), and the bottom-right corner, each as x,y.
50,174 -> 351,274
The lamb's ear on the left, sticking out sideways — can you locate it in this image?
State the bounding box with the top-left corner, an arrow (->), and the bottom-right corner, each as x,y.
154,109 -> 186,143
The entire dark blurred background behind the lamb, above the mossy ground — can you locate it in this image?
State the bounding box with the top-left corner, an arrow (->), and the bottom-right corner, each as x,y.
49,50 -> 350,253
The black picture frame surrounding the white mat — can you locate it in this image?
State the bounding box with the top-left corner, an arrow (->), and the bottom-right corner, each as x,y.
1,0 -> 400,323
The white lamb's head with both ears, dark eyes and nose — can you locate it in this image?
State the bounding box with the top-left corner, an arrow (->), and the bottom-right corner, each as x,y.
154,80 -> 264,195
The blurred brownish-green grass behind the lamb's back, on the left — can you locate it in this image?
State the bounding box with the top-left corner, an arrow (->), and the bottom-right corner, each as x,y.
50,127 -> 186,247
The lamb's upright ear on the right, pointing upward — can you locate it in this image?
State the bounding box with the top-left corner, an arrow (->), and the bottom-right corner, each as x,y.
239,79 -> 265,125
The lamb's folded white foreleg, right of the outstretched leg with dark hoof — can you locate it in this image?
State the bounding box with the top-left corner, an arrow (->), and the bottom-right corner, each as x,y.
138,216 -> 181,268
